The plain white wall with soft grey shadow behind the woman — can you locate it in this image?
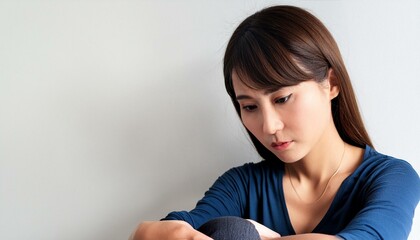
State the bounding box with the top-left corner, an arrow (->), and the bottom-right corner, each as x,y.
0,0 -> 420,240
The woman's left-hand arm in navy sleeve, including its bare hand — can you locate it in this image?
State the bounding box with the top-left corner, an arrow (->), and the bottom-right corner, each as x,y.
130,166 -> 251,240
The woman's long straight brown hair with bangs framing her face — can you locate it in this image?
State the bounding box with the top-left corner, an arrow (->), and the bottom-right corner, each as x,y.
223,6 -> 373,159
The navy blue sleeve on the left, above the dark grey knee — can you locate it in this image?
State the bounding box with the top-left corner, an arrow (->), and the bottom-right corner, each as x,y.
162,165 -> 249,229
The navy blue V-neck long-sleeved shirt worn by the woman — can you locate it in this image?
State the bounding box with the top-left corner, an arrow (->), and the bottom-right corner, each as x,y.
163,146 -> 420,240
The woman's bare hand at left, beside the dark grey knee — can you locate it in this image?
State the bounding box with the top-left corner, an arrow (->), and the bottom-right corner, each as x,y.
130,220 -> 212,240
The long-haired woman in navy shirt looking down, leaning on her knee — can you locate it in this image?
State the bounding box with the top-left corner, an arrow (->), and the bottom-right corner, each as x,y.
130,6 -> 420,240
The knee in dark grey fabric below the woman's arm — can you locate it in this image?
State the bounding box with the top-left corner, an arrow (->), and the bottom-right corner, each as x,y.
198,217 -> 260,240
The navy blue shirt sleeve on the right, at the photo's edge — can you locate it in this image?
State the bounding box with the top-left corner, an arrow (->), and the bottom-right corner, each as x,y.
337,160 -> 420,240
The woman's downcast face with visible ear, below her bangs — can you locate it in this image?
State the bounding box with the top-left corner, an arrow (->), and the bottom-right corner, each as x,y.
232,71 -> 338,163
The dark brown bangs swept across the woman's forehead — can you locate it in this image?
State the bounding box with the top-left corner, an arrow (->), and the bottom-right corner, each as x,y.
226,29 -> 311,90
